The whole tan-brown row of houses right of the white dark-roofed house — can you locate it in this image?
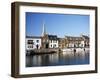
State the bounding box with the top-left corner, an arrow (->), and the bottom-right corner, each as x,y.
59,35 -> 89,49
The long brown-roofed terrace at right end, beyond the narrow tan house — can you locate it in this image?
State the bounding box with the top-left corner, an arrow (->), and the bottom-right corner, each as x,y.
65,35 -> 89,47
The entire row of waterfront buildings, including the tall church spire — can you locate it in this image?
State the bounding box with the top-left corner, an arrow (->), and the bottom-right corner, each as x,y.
26,22 -> 89,50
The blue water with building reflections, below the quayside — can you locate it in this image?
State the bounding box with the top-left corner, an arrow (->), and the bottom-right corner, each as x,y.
26,51 -> 89,67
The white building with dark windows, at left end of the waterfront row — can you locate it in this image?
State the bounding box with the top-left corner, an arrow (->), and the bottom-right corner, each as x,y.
26,36 -> 41,50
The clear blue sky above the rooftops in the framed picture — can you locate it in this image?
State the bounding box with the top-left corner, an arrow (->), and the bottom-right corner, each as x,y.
26,12 -> 90,37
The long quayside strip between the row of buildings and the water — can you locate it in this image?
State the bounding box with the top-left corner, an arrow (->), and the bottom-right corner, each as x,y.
26,48 -> 89,55
